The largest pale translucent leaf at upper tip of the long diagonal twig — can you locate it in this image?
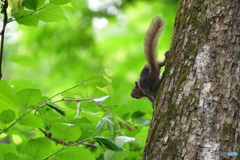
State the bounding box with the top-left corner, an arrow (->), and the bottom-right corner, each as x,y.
80,71 -> 109,87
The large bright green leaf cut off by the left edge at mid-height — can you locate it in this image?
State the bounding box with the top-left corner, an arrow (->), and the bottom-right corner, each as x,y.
0,80 -> 20,115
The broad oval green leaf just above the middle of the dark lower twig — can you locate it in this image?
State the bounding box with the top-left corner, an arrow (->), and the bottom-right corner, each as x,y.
51,123 -> 81,142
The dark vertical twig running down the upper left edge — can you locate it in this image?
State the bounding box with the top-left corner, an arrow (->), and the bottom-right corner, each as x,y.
0,0 -> 8,80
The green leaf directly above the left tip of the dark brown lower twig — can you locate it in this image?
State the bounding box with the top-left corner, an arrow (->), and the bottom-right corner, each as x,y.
19,113 -> 44,128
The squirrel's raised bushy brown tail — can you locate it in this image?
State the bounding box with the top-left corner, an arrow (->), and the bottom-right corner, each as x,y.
144,15 -> 164,70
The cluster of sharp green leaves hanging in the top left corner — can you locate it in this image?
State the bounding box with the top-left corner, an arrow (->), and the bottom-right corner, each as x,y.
9,0 -> 68,26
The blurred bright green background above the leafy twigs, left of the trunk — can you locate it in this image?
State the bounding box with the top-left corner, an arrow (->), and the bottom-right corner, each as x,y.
3,0 -> 177,101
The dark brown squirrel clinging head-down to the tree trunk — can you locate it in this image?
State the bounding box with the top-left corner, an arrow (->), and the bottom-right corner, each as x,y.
131,15 -> 169,104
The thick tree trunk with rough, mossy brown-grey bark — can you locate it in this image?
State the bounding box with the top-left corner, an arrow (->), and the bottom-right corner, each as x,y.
143,0 -> 240,160
